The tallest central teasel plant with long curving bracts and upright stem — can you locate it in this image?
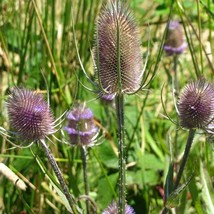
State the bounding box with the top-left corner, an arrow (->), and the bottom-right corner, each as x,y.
69,0 -> 170,211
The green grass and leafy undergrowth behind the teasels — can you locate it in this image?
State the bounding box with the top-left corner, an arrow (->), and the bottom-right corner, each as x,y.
0,0 -> 214,214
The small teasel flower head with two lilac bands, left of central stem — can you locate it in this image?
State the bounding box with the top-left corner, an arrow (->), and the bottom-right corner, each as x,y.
65,105 -> 98,146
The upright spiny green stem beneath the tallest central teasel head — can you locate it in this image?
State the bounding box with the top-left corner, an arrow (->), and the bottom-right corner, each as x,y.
116,94 -> 126,214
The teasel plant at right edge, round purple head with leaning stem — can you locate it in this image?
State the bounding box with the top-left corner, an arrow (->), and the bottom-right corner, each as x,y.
162,77 -> 214,214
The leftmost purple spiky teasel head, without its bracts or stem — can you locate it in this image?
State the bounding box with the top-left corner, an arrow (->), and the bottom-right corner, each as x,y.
7,88 -> 54,142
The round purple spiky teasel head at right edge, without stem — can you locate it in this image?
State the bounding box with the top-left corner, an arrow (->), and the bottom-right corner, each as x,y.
178,80 -> 214,129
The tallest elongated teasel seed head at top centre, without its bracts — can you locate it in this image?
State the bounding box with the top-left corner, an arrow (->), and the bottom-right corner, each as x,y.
94,1 -> 142,94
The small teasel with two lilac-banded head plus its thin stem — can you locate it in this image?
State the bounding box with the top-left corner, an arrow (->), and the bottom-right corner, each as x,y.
64,103 -> 99,214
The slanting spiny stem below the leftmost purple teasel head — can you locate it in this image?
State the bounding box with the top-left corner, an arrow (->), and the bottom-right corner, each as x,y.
40,140 -> 78,214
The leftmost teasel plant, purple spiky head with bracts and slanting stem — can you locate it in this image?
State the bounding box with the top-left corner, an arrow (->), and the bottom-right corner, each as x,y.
1,87 -> 82,214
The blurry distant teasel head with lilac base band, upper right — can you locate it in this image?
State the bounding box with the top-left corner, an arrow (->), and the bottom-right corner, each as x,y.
164,21 -> 187,55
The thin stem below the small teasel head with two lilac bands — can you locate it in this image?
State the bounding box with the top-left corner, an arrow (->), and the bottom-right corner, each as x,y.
81,147 -> 90,214
